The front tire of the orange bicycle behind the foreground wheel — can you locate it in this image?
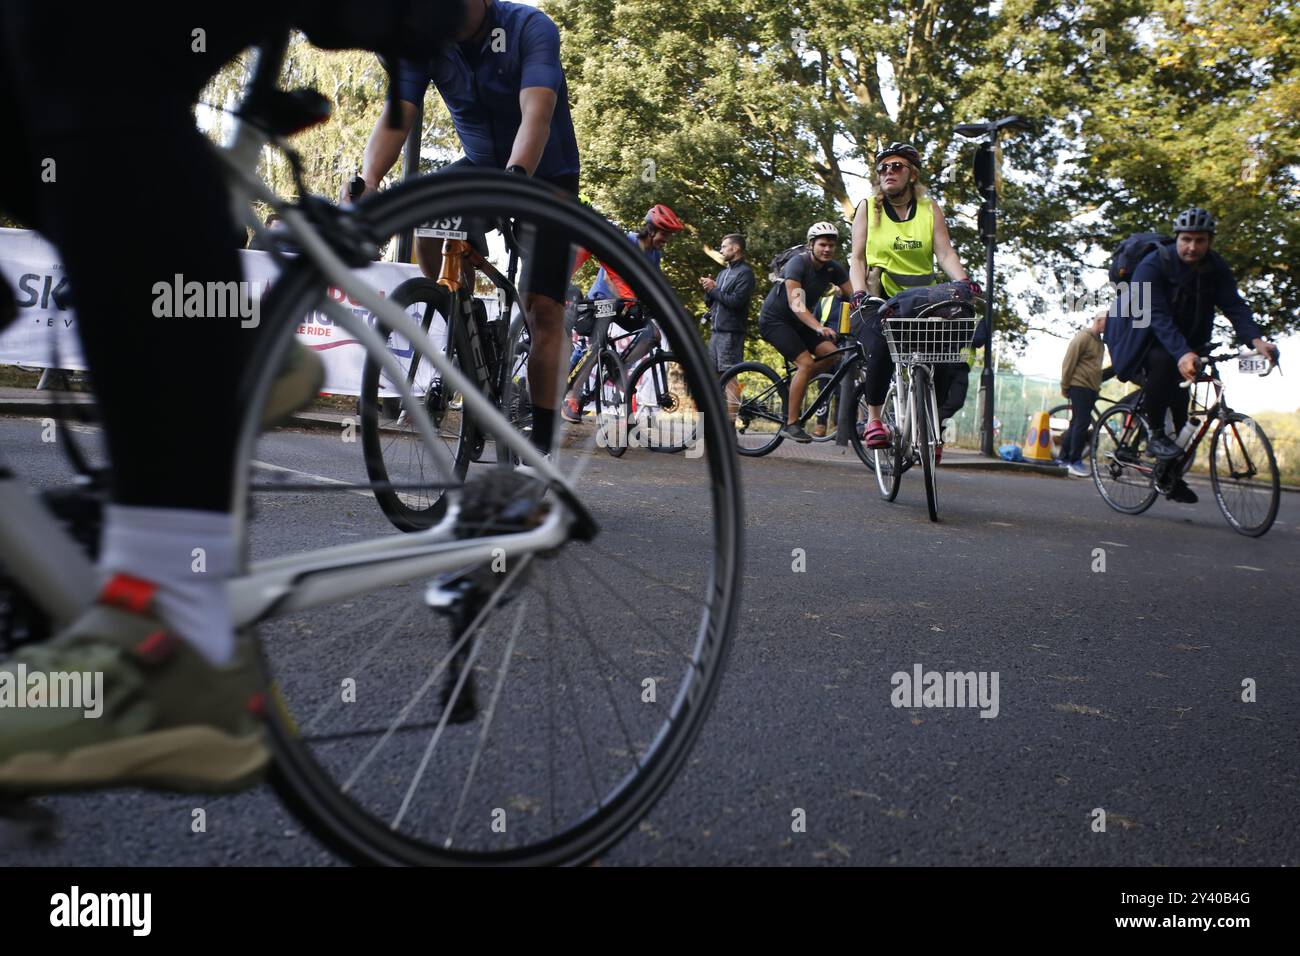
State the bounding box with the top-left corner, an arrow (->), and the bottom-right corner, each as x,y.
359,276 -> 475,532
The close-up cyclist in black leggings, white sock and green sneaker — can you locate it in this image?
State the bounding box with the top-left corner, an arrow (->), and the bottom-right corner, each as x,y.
0,0 -> 463,792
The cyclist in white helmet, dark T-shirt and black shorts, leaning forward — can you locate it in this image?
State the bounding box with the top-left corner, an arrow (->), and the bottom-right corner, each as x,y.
758,221 -> 852,444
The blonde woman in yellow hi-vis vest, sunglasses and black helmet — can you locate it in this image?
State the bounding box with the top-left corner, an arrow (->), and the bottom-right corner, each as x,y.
849,143 -> 967,449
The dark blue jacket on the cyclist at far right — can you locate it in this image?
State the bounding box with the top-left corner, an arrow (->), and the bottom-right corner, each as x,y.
1105,245 -> 1264,381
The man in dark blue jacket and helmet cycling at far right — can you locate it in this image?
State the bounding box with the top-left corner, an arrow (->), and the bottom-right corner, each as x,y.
1106,208 -> 1278,503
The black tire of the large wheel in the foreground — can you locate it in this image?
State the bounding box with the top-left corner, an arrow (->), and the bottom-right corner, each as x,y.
234,172 -> 744,865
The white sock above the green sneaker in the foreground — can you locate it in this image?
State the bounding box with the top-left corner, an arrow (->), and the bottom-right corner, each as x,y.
99,505 -> 235,663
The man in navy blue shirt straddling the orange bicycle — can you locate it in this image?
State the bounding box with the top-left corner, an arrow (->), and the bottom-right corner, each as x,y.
361,0 -> 579,451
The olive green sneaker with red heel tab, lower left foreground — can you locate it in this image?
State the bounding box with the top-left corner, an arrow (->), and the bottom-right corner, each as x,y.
0,575 -> 270,793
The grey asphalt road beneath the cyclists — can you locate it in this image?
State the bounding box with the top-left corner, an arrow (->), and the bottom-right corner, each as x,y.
0,420 -> 1300,866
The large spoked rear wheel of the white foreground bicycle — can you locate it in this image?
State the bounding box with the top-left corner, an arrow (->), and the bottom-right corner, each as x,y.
243,172 -> 744,865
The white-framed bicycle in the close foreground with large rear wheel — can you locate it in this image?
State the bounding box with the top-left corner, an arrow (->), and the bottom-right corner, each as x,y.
0,36 -> 744,865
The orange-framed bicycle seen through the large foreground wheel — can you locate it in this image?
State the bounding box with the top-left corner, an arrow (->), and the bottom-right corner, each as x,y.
358,216 -> 527,531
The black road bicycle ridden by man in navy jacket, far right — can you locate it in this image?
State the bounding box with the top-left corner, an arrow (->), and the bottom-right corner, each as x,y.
1091,346 -> 1282,537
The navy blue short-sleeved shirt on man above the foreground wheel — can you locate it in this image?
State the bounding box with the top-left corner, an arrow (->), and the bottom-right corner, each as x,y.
398,0 -> 579,178
